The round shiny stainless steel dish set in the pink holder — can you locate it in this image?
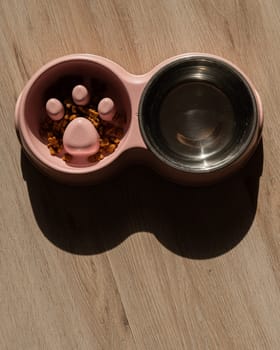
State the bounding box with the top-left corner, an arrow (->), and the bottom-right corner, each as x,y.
139,57 -> 257,172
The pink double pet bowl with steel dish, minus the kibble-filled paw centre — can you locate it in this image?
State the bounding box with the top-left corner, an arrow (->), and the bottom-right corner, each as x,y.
15,53 -> 263,185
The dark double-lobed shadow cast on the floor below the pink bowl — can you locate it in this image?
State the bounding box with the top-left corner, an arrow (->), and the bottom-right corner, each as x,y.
21,142 -> 263,259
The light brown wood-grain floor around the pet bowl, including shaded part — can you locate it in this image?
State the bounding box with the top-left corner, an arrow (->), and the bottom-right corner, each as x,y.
0,0 -> 280,350
